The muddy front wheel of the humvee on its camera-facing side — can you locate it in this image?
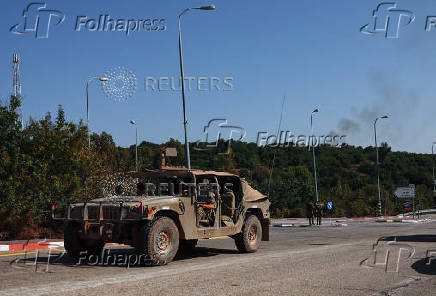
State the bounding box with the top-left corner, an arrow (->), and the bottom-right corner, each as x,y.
138,217 -> 179,265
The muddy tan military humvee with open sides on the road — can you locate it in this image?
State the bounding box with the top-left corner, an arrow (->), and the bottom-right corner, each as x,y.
52,169 -> 270,265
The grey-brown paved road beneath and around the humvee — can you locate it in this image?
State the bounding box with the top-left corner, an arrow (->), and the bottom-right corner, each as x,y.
0,222 -> 436,296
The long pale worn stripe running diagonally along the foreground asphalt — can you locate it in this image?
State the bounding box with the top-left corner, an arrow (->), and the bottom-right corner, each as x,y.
0,240 -> 367,296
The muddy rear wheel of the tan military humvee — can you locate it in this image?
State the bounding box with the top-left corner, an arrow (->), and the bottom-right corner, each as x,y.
234,215 -> 262,253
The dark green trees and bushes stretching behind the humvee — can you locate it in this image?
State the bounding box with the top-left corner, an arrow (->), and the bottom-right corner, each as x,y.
0,97 -> 434,240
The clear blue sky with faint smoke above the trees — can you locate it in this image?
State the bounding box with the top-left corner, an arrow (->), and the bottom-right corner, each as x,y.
0,0 -> 436,153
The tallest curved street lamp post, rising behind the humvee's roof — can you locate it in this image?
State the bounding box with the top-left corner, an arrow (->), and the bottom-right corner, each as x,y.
179,5 -> 215,170
